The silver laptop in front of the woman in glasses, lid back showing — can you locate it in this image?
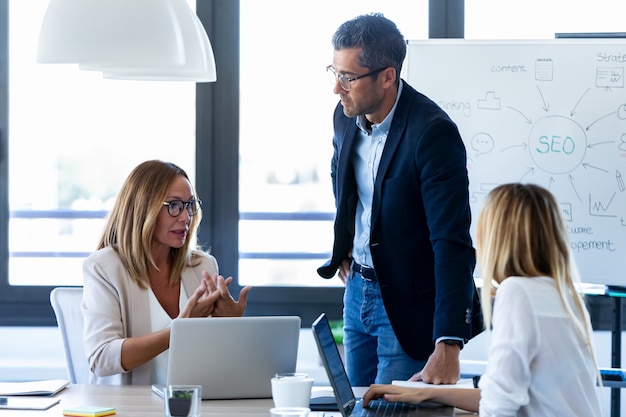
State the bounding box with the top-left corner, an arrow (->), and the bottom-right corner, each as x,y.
153,316 -> 300,400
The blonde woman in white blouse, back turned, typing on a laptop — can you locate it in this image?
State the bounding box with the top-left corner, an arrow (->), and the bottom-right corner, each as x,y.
364,183 -> 601,417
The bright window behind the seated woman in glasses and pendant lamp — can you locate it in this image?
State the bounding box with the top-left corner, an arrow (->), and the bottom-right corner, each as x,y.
0,0 -> 195,321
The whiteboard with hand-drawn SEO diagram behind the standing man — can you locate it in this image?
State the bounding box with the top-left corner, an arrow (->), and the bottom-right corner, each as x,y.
402,39 -> 626,285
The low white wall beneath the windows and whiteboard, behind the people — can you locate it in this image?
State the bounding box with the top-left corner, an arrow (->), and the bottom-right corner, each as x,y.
0,327 -> 626,416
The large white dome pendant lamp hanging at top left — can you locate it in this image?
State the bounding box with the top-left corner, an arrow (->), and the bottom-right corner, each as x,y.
37,0 -> 217,82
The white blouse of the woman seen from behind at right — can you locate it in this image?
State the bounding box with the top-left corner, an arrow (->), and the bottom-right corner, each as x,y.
479,277 -> 601,417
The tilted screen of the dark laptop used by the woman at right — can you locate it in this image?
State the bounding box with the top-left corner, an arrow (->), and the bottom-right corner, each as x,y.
311,313 -> 356,416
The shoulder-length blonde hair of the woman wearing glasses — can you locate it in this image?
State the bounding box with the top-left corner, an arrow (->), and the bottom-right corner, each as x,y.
97,160 -> 202,288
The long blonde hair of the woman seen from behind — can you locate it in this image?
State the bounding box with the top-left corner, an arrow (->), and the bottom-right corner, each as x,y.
476,183 -> 593,356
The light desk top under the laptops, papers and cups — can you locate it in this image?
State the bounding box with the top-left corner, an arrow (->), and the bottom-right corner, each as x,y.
0,385 -> 468,417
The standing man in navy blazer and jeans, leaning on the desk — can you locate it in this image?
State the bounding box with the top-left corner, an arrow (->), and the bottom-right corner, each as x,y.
318,14 -> 483,386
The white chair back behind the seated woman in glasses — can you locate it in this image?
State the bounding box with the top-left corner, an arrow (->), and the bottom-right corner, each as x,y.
50,287 -> 90,384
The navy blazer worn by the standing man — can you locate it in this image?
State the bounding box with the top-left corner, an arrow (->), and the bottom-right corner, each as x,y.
318,81 -> 483,360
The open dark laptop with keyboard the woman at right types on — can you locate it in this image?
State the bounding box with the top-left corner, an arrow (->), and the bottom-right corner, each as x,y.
311,313 -> 454,417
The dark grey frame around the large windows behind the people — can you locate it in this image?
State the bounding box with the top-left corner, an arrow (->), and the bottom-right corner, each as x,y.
0,0 -> 464,327
